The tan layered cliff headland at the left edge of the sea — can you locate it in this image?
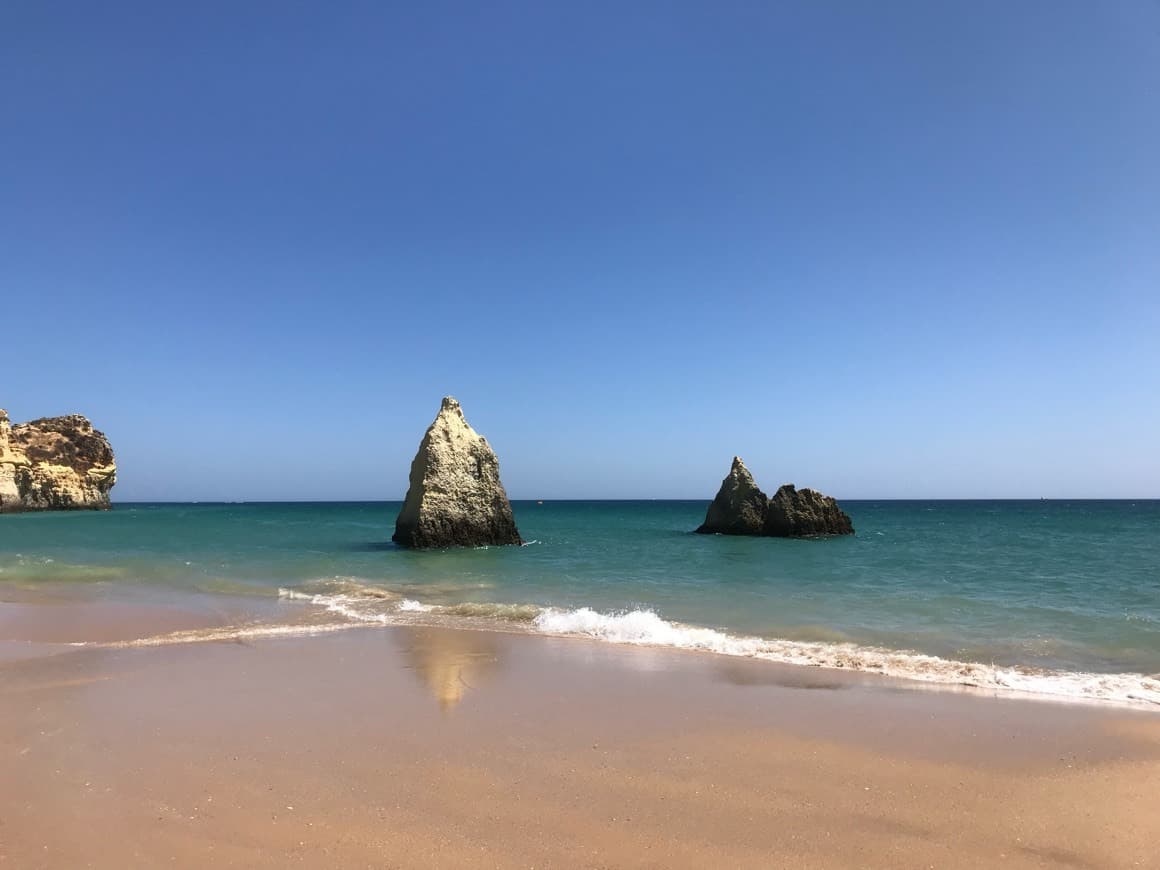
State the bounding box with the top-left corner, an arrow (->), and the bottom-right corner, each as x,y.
0,409 -> 117,514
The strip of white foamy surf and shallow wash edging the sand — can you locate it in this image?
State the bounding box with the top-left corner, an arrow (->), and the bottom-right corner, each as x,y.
0,588 -> 1160,712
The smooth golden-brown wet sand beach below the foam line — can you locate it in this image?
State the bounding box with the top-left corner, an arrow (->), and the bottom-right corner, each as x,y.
0,610 -> 1160,868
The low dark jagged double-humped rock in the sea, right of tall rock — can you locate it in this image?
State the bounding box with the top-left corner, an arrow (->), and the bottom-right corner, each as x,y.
697,456 -> 854,538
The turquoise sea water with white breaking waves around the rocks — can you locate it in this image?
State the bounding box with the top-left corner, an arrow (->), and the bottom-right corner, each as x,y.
0,501 -> 1160,703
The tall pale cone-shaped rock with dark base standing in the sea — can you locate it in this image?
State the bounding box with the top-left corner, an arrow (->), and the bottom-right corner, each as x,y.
393,396 -> 523,549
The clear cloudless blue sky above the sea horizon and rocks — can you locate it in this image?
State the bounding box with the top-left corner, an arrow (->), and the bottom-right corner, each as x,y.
0,0 -> 1160,501
